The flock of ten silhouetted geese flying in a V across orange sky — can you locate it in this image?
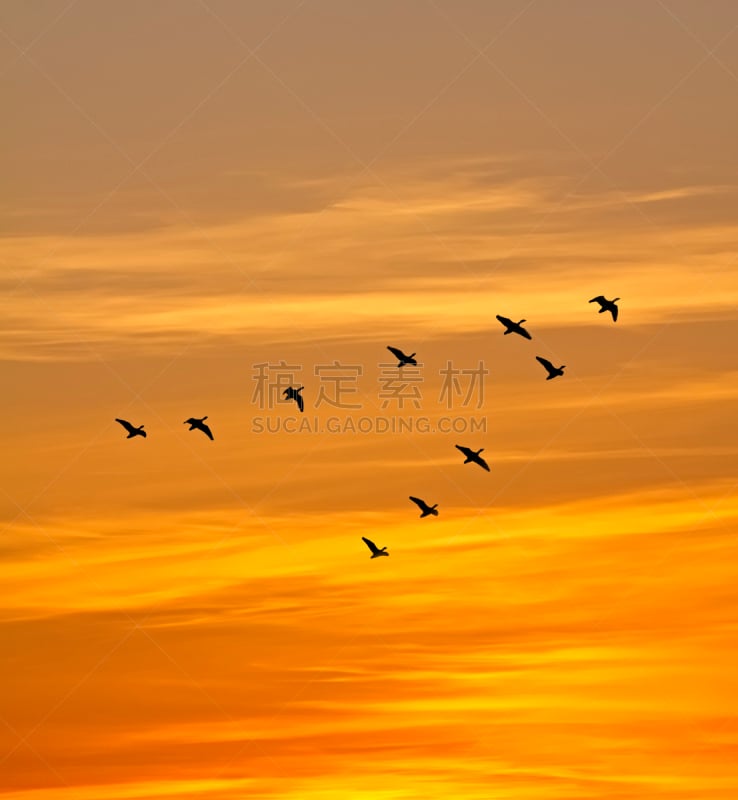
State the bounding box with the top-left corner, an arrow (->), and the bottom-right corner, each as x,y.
115,294 -> 620,558
